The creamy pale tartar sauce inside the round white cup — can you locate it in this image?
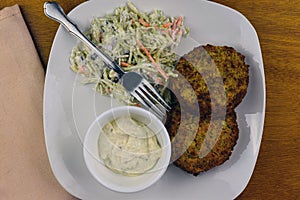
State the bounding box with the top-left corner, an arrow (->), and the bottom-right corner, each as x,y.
98,117 -> 162,176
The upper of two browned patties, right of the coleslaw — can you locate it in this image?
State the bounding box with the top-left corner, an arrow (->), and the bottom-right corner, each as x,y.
170,45 -> 249,115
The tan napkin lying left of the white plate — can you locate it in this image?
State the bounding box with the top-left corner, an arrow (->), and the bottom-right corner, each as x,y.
0,5 -> 77,200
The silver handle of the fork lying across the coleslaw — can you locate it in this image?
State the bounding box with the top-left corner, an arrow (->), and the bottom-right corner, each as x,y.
44,2 -> 125,77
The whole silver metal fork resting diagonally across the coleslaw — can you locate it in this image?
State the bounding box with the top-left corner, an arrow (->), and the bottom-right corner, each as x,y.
44,2 -> 170,120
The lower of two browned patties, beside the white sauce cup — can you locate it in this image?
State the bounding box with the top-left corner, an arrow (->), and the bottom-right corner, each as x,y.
166,105 -> 239,176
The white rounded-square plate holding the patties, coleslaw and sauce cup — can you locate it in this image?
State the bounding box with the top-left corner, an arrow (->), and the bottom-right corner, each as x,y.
44,0 -> 266,200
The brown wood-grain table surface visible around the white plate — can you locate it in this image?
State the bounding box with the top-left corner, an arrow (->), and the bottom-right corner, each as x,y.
0,0 -> 300,199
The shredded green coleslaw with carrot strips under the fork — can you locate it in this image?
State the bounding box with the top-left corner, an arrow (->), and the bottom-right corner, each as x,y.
70,2 -> 188,105
